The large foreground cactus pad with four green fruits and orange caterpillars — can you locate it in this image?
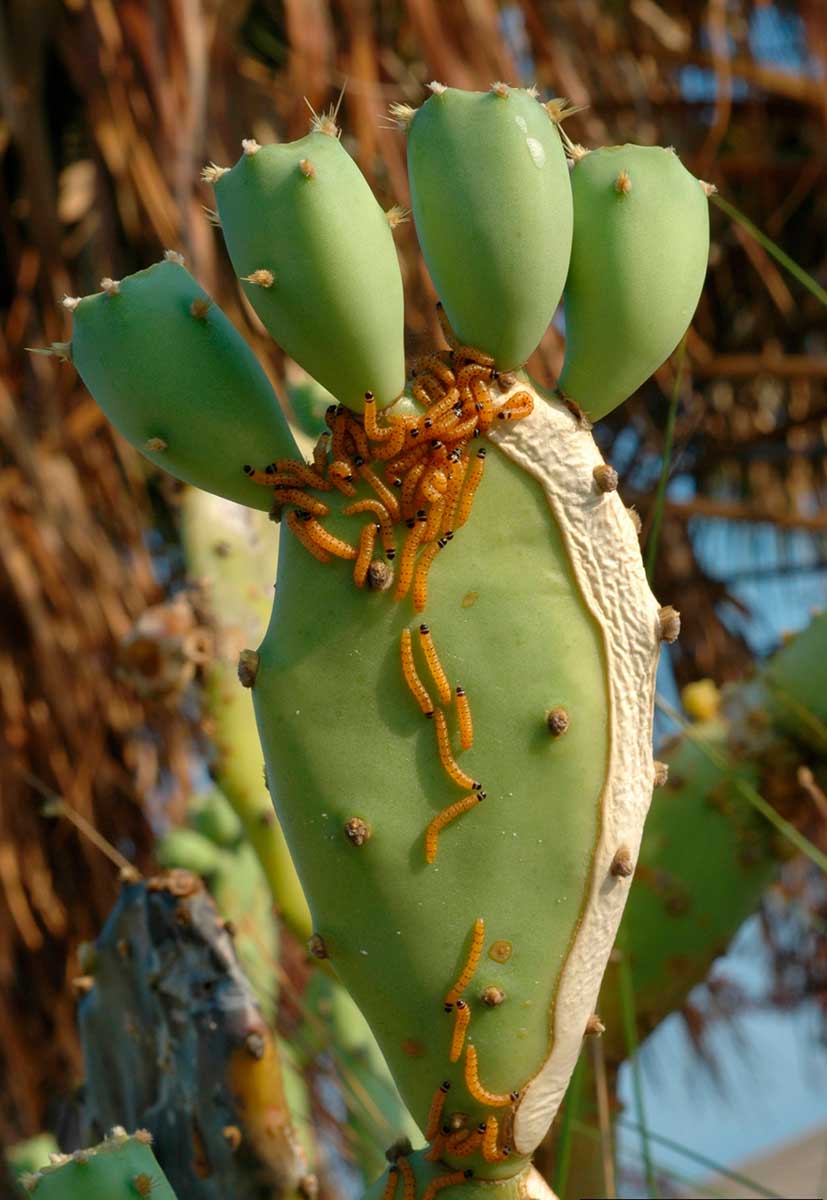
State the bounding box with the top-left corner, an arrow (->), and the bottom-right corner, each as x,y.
61,84 -> 707,1200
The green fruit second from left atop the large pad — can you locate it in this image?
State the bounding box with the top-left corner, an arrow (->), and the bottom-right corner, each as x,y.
215,132 -> 404,412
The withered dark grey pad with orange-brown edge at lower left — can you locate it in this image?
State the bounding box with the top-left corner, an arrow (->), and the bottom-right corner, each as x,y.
77,869 -> 312,1200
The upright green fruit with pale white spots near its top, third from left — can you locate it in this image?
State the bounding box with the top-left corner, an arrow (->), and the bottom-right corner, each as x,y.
408,84 -> 571,371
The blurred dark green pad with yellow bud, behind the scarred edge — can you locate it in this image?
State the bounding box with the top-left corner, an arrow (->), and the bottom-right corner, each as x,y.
600,721 -> 778,1062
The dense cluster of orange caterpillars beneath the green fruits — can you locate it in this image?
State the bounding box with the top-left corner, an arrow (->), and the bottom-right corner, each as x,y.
244,328 -> 534,612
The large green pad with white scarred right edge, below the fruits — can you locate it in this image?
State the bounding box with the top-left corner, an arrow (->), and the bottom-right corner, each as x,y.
252,385 -> 661,1180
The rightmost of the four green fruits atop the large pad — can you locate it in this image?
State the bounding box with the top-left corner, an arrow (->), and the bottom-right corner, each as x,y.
559,145 -> 709,420
